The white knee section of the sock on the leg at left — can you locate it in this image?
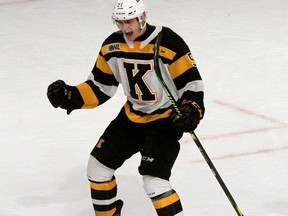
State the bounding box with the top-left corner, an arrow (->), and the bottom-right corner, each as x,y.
87,155 -> 115,182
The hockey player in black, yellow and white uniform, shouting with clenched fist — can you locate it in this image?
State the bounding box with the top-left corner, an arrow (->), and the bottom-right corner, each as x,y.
47,0 -> 204,216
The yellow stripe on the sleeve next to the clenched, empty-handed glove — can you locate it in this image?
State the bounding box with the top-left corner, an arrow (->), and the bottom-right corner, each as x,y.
76,82 -> 99,109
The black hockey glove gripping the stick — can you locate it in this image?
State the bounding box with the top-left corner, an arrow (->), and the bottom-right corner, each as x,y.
172,100 -> 202,132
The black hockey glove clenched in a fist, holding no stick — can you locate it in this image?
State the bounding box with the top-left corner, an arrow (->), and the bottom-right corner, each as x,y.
47,80 -> 76,115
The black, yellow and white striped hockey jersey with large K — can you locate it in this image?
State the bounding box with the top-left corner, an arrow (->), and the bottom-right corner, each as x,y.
76,25 -> 204,123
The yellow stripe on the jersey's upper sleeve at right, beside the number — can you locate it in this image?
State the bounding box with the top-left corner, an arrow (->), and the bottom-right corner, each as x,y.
169,55 -> 195,79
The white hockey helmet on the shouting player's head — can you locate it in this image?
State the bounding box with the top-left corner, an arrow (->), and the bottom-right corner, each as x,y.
112,0 -> 147,26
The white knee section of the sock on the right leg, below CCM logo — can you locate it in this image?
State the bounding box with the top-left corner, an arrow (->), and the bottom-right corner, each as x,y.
143,175 -> 172,198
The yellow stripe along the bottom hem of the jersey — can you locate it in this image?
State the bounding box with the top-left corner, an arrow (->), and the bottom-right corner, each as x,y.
124,103 -> 172,123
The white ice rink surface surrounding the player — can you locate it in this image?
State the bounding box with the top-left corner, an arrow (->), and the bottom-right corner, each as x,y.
0,0 -> 288,216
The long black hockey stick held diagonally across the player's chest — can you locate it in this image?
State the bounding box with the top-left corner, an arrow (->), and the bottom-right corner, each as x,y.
153,31 -> 244,216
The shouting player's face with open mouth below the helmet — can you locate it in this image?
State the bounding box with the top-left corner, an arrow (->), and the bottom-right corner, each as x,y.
116,18 -> 143,41
